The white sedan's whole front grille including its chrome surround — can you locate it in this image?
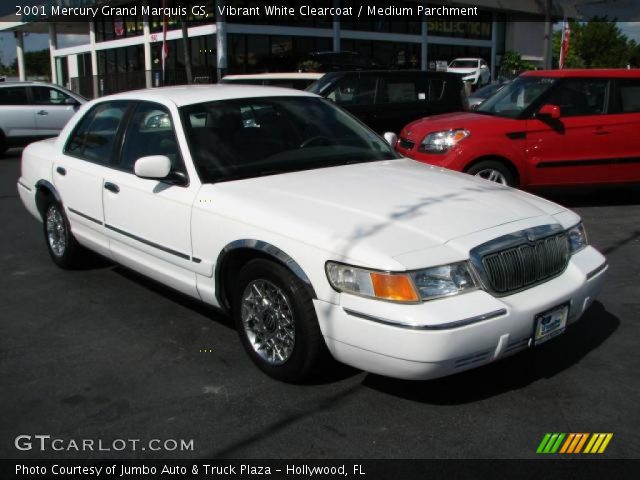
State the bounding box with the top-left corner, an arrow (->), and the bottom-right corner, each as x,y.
471,225 -> 570,296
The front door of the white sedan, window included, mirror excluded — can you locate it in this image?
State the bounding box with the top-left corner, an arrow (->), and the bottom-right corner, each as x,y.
102,102 -> 199,297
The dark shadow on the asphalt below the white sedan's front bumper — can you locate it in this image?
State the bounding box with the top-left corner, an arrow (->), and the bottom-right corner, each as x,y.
363,302 -> 620,405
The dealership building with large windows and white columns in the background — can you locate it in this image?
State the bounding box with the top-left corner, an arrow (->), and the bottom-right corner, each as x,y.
0,0 -> 564,97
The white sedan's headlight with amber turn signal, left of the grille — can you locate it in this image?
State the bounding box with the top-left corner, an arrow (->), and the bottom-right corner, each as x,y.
326,262 -> 477,303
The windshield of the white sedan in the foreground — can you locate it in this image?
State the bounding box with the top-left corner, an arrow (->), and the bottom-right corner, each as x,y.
181,97 -> 399,183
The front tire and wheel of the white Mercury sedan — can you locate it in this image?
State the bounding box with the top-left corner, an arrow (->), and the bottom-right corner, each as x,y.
233,259 -> 327,383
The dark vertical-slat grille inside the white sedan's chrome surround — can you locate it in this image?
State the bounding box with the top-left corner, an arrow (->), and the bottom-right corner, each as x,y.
482,232 -> 569,294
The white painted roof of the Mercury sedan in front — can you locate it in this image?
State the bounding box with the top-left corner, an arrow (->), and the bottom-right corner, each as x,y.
100,84 -> 317,107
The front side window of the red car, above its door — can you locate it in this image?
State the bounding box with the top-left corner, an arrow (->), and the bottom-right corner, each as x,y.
547,78 -> 609,117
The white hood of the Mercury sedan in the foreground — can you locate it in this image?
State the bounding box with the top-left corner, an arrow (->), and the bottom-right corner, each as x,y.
201,159 -> 564,268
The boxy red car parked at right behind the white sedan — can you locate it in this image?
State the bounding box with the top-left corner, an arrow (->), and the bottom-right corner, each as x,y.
396,69 -> 640,187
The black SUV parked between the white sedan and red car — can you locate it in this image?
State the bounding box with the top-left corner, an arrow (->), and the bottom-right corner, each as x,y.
307,70 -> 464,133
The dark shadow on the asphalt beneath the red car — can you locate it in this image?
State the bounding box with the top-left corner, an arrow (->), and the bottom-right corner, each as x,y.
531,185 -> 640,208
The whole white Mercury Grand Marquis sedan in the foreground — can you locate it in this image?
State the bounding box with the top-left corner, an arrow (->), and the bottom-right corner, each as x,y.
18,85 -> 607,382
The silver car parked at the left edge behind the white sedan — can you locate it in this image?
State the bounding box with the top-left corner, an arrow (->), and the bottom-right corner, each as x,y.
0,82 -> 86,154
